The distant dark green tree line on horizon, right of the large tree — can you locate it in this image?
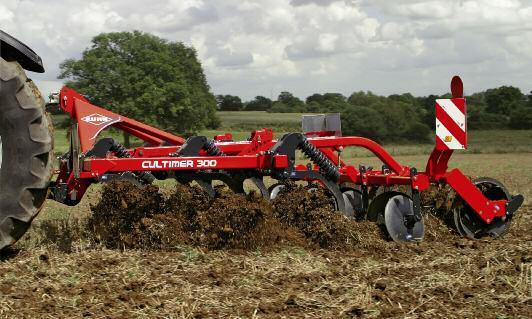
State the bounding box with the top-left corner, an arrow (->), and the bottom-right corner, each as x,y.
216,86 -> 532,141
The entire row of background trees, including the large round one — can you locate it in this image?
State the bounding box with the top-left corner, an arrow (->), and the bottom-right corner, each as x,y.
59,31 -> 532,144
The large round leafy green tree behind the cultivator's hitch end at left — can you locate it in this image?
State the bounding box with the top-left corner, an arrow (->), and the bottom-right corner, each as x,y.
59,31 -> 219,142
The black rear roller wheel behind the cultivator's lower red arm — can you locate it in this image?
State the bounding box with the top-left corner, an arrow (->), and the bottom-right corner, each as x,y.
453,177 -> 512,239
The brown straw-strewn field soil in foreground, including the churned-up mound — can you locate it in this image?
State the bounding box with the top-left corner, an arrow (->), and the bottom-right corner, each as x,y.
0,183 -> 532,318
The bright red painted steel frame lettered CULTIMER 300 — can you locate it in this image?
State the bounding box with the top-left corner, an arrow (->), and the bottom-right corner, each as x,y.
57,79 -> 506,224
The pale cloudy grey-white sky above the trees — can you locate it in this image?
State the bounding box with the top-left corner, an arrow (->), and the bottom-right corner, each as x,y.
0,0 -> 532,100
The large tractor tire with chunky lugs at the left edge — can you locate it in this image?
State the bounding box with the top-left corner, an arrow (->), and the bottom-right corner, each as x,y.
0,58 -> 53,250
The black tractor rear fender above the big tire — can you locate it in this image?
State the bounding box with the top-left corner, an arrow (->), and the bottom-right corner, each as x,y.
0,30 -> 44,73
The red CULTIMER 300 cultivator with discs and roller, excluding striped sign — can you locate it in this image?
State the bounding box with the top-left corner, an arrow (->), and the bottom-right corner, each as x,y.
51,77 -> 523,241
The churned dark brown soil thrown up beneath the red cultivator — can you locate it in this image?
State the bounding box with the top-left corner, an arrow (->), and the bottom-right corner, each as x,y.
88,181 -> 454,251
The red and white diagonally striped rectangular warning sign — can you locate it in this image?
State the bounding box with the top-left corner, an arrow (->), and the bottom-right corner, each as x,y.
436,98 -> 467,150
